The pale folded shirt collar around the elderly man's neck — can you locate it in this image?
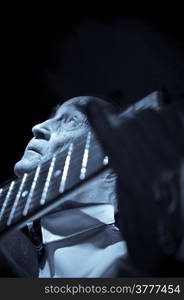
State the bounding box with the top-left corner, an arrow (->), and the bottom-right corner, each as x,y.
41,204 -> 115,243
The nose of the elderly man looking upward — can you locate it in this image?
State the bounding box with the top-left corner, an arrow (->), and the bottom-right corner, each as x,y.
32,120 -> 51,140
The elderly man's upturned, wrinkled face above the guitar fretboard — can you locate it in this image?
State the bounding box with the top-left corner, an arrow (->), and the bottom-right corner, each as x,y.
14,97 -> 110,176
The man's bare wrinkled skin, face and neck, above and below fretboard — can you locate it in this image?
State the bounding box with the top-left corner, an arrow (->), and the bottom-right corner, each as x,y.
14,96 -> 117,210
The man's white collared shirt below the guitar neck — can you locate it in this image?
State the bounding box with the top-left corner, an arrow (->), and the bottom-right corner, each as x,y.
39,204 -> 127,278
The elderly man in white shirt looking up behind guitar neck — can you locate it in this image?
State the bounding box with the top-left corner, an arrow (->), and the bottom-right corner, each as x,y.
10,97 -> 126,277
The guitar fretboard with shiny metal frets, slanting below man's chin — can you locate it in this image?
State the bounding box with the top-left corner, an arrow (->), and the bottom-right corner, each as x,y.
0,131 -> 108,236
